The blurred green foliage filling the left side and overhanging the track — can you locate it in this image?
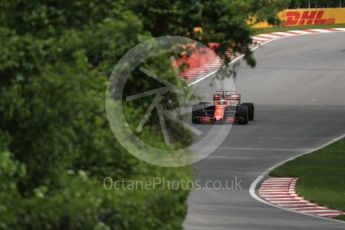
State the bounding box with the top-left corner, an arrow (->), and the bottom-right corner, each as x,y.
0,0 -> 279,229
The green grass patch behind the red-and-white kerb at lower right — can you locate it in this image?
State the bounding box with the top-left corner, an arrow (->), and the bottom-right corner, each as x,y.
270,139 -> 345,220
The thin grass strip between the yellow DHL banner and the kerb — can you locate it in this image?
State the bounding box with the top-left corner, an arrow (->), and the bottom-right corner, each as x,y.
253,24 -> 345,35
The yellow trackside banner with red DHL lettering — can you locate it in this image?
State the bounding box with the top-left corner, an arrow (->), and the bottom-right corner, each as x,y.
252,8 -> 345,28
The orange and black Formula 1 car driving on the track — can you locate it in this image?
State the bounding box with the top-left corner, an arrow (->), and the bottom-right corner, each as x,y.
192,91 -> 254,124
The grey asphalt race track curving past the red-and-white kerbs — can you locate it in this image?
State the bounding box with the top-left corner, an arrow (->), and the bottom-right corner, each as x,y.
184,33 -> 345,230
